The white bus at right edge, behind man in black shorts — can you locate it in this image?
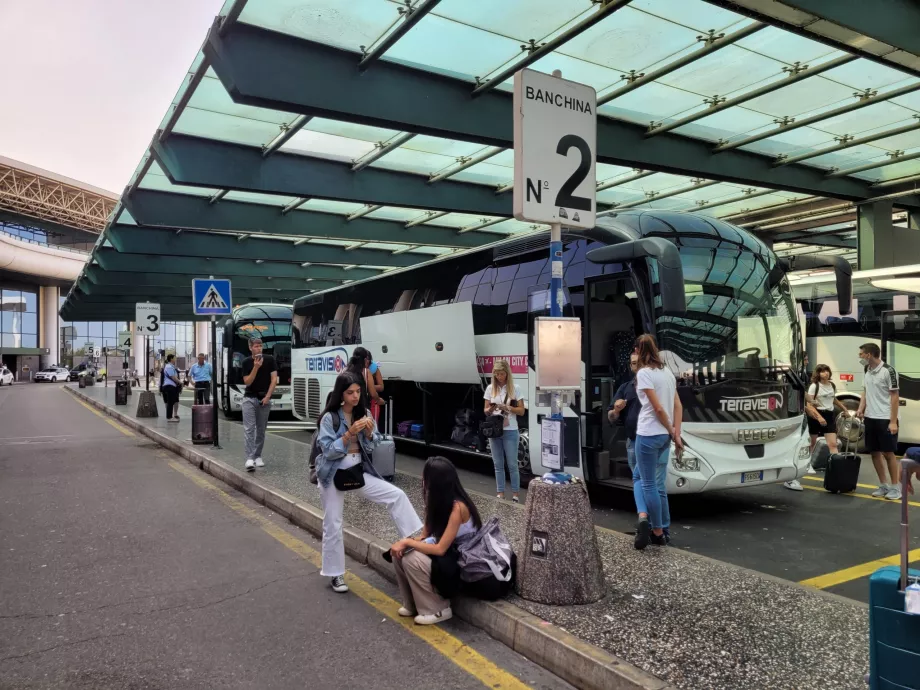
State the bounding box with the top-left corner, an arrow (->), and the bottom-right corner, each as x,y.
790,265 -> 920,444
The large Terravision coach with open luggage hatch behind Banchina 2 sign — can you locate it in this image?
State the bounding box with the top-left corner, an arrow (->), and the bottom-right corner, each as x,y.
292,210 -> 849,493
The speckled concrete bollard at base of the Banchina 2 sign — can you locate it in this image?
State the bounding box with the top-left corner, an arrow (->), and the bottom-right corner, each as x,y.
515,480 -> 605,606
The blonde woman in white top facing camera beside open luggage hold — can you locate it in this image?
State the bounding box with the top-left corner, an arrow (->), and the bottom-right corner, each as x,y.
483,359 -> 524,503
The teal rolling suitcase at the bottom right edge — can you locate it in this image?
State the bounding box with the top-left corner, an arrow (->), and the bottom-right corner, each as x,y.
868,458 -> 920,690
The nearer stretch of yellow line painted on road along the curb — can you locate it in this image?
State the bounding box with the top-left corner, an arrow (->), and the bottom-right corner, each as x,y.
162,453 -> 528,690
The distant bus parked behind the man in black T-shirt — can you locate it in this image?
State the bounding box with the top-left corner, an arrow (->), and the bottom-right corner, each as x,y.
214,303 -> 293,417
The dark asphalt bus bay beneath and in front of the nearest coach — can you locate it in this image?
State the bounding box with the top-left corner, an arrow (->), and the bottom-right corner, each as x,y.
203,398 -> 920,601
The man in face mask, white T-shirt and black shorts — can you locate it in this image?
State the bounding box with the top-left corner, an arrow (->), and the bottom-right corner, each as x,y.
856,343 -> 901,501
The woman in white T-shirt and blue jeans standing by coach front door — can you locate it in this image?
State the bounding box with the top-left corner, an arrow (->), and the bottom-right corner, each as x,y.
634,334 -> 684,549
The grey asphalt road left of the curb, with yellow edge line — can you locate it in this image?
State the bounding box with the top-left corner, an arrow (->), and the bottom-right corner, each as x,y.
0,384 -> 569,690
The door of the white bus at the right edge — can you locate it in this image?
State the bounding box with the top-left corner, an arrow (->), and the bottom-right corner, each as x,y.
882,309 -> 920,444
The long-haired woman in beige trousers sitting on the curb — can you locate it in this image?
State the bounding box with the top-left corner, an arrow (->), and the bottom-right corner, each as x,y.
390,456 -> 482,625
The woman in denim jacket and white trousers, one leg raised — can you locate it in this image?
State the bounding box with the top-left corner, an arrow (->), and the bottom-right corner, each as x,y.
316,372 -> 422,593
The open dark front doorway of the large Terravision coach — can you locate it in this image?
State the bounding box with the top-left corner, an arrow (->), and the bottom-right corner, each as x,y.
583,272 -> 643,486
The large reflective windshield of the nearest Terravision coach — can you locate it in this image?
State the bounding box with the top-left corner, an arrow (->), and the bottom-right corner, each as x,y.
652,244 -> 802,385
